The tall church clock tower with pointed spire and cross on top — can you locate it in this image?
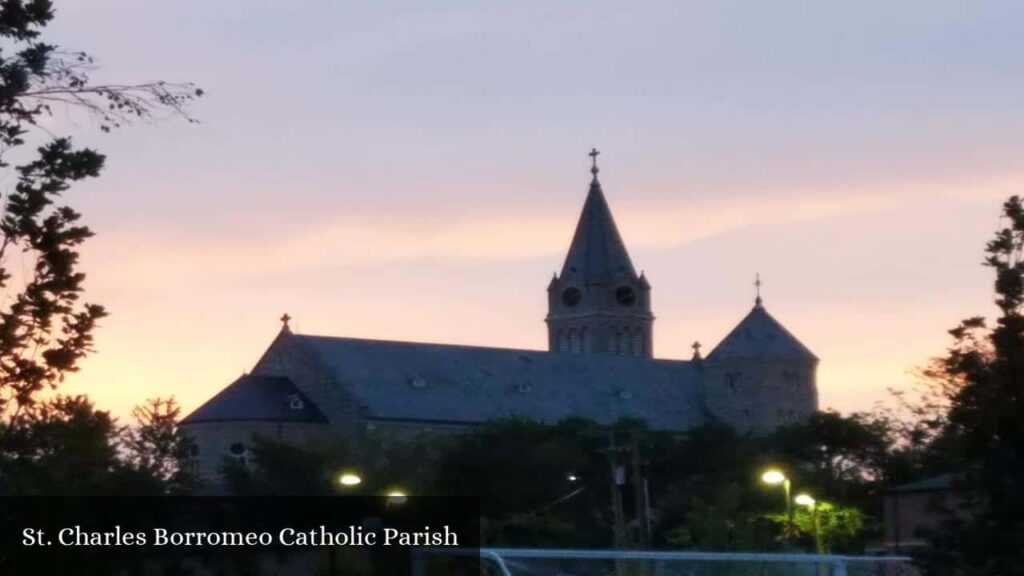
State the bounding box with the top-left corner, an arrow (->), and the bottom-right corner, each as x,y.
547,149 -> 654,358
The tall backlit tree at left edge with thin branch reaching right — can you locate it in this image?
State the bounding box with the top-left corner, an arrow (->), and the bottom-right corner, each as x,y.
0,0 -> 202,422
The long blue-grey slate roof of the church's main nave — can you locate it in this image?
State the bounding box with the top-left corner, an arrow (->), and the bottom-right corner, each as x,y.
292,335 -> 703,429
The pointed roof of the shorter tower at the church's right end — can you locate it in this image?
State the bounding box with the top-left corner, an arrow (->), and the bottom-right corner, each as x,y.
708,300 -> 818,361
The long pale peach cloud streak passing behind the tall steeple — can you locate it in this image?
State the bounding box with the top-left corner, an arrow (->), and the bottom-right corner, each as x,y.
91,171 -> 1024,295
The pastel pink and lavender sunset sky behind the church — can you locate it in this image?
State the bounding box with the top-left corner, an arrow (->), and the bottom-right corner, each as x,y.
48,0 -> 1024,415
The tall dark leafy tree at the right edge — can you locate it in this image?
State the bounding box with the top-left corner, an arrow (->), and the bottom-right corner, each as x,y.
922,196 -> 1024,576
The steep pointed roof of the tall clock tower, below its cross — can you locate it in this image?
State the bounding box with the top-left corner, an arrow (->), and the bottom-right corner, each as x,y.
561,174 -> 637,285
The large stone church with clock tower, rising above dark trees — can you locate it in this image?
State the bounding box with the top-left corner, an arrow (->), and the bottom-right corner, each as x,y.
181,151 -> 818,480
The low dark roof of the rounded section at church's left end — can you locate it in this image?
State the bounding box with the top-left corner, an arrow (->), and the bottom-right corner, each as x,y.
181,374 -> 327,424
